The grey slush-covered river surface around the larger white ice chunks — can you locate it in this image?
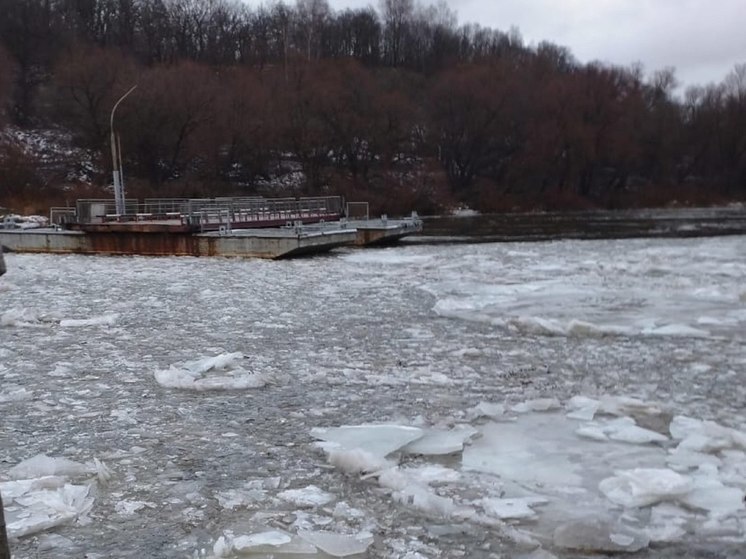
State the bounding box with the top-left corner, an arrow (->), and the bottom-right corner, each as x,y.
0,237 -> 746,559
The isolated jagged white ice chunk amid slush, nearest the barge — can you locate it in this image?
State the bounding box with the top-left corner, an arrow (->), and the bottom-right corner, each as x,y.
155,353 -> 267,391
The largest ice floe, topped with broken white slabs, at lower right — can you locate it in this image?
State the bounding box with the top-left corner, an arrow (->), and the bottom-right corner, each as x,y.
312,396 -> 746,552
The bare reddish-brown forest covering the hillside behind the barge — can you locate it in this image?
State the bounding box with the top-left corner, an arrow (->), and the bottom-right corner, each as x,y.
0,0 -> 746,214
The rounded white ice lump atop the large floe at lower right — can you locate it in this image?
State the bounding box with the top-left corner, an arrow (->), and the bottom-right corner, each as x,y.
598,468 -> 692,507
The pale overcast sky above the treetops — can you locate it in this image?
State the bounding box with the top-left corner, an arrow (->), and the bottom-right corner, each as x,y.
310,0 -> 746,85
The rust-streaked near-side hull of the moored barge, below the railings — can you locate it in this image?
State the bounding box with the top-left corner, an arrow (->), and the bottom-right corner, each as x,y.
0,229 -> 357,259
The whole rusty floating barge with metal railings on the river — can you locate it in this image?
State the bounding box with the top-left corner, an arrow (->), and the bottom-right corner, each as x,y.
0,196 -> 422,258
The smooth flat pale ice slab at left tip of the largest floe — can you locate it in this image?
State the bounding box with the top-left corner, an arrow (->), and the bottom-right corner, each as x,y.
311,424 -> 424,458
